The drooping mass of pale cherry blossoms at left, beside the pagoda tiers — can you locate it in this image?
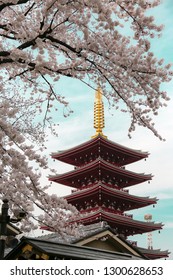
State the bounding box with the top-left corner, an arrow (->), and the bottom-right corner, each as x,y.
0,85 -> 77,236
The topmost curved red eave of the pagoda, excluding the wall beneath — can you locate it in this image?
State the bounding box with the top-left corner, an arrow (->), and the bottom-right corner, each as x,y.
51,136 -> 149,166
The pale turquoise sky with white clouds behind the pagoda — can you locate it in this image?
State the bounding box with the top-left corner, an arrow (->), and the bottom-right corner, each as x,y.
36,0 -> 173,259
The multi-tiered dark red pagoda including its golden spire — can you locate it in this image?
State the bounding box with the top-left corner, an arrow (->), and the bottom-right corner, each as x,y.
49,88 -> 169,258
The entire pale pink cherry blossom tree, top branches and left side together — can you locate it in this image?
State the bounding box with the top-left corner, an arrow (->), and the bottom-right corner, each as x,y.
0,0 -> 173,234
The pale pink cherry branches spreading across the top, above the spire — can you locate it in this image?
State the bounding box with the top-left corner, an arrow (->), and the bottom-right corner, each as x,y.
0,0 -> 172,138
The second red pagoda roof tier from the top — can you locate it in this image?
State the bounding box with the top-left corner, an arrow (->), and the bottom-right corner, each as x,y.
49,158 -> 152,188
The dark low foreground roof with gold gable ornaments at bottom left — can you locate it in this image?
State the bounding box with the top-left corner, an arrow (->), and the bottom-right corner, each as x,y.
4,237 -> 145,260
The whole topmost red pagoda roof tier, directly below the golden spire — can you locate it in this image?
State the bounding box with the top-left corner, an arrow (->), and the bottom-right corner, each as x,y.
51,135 -> 149,166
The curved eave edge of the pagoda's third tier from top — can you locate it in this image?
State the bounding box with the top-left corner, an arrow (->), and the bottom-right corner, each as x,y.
64,183 -> 157,211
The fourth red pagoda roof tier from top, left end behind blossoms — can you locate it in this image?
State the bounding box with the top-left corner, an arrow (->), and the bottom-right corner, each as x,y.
75,207 -> 163,236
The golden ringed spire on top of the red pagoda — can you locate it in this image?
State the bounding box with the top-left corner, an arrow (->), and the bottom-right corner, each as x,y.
91,87 -> 107,138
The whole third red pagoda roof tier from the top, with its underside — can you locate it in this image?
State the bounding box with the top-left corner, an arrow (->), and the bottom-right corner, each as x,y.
64,182 -> 157,211
